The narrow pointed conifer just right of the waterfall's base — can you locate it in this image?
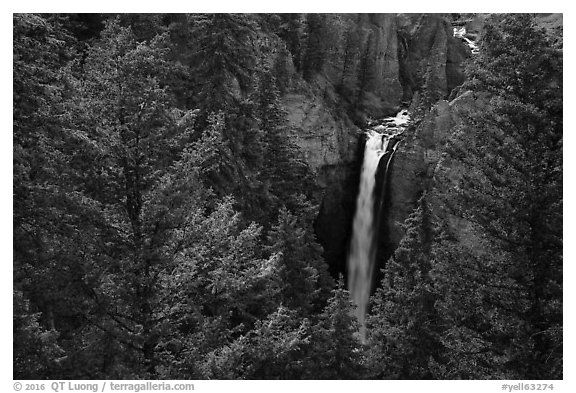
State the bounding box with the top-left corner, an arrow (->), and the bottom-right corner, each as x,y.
368,196 -> 441,379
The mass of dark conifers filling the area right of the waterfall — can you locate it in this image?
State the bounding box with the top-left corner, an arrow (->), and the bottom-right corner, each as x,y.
371,15 -> 562,379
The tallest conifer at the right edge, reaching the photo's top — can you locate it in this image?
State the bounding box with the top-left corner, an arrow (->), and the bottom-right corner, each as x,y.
436,14 -> 562,378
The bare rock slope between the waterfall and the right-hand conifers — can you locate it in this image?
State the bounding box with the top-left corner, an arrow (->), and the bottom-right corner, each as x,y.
384,92 -> 482,253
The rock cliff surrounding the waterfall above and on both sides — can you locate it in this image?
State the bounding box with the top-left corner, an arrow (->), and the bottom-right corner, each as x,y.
283,14 -> 470,272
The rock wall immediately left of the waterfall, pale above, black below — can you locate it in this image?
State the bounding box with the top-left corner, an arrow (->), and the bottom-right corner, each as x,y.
283,93 -> 362,276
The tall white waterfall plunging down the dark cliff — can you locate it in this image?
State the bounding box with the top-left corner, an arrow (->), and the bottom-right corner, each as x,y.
347,111 -> 409,343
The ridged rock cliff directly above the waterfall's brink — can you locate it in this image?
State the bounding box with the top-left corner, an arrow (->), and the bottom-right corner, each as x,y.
352,14 -> 471,118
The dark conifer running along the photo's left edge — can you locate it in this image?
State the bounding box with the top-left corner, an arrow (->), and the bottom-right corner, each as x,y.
13,14 -> 89,368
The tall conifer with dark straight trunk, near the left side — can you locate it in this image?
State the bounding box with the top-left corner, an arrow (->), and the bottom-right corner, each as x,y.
56,20 -> 186,376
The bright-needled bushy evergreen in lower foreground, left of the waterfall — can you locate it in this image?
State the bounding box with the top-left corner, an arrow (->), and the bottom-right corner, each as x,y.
158,193 -> 278,378
